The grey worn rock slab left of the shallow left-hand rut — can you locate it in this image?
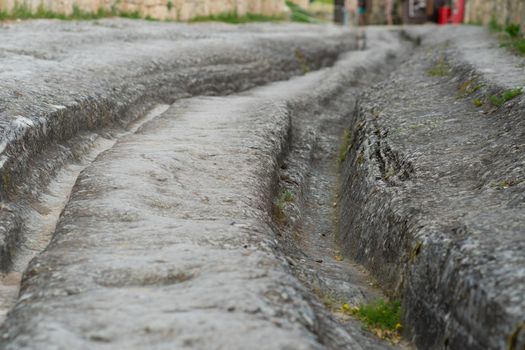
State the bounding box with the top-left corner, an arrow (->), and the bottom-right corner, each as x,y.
0,19 -> 355,270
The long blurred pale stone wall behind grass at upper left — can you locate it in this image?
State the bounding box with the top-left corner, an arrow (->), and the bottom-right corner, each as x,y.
0,0 -> 308,21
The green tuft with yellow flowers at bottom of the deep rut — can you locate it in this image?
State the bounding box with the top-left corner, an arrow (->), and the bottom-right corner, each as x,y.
341,299 -> 402,340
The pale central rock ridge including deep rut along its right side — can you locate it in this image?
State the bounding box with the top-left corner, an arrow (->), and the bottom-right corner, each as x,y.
0,30 -> 411,349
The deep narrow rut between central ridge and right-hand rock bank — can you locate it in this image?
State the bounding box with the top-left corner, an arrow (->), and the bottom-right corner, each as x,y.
274,31 -> 412,349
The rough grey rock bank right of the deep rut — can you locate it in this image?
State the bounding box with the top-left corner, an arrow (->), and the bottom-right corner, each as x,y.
339,27 -> 525,349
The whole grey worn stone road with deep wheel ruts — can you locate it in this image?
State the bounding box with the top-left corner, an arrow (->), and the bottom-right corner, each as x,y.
0,19 -> 525,349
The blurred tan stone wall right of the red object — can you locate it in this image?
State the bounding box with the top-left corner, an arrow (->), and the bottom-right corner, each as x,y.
465,0 -> 525,29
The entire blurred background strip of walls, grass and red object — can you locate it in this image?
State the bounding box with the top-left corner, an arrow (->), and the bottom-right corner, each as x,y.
0,0 -> 525,28
